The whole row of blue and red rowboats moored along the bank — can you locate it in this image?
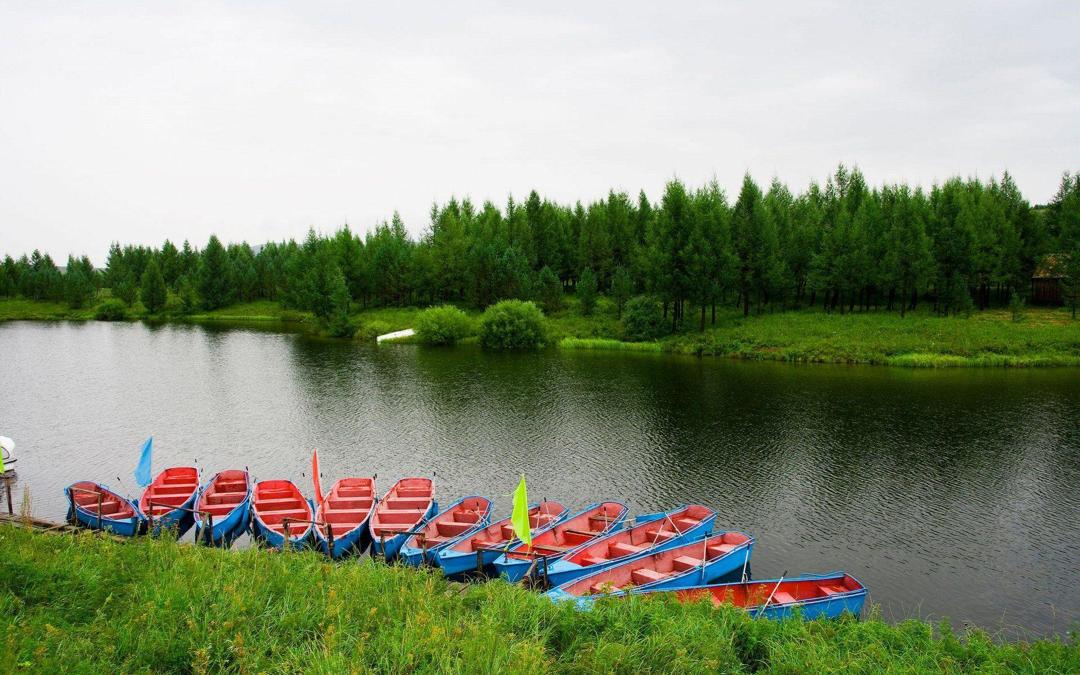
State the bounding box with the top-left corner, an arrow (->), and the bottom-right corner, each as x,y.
65,467 -> 866,618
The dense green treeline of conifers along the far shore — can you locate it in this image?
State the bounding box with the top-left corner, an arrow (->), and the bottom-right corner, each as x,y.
0,165 -> 1080,329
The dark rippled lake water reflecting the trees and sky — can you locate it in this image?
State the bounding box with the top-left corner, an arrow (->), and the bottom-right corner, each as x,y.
0,322 -> 1080,637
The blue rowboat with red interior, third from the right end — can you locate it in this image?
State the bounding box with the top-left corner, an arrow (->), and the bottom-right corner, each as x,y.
546,504 -> 716,586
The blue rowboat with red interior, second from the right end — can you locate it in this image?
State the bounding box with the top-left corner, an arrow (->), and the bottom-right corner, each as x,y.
546,532 -> 754,607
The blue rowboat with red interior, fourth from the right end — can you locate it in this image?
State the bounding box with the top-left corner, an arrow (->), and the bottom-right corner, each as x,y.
491,501 -> 630,581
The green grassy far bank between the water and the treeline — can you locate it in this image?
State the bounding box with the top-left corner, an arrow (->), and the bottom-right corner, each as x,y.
6,298 -> 1080,367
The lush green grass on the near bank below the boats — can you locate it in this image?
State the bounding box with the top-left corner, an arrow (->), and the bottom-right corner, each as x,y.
0,526 -> 1080,673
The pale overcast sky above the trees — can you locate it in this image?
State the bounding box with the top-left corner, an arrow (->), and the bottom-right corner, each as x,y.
0,0 -> 1080,264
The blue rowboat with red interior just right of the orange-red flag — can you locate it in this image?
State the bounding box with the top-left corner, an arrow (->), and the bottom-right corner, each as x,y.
314,478 -> 379,559
